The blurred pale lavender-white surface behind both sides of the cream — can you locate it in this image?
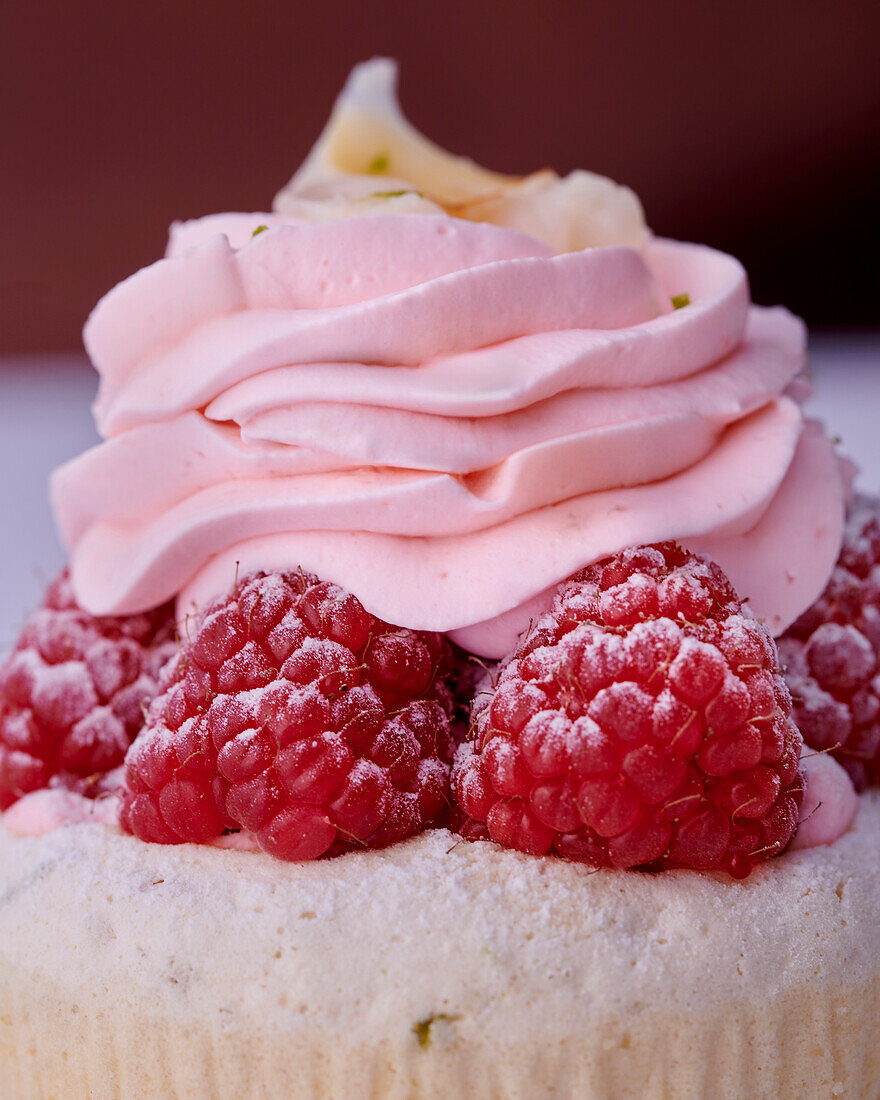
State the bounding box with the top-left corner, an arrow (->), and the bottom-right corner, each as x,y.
0,334 -> 880,651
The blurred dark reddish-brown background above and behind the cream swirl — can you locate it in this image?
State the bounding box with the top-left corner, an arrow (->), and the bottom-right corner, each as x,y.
0,0 -> 880,352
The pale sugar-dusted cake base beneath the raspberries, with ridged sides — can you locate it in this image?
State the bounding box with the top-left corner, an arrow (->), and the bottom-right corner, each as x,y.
0,793 -> 880,1100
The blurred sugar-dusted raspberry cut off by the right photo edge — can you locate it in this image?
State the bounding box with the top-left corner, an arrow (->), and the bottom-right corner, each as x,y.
779,497 -> 880,791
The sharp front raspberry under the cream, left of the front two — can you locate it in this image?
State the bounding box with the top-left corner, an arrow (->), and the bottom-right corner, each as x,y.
122,572 -> 453,860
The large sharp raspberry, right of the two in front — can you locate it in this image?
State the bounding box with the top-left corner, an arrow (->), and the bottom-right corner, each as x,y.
453,542 -> 803,878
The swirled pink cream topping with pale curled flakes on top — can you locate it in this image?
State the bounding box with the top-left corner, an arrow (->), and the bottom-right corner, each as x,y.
53,62 -> 844,657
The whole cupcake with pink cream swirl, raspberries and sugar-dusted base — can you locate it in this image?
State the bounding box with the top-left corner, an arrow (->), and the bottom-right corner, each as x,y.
0,61 -> 880,1100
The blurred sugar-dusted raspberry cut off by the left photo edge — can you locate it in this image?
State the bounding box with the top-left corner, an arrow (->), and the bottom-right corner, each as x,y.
0,571 -> 177,810
